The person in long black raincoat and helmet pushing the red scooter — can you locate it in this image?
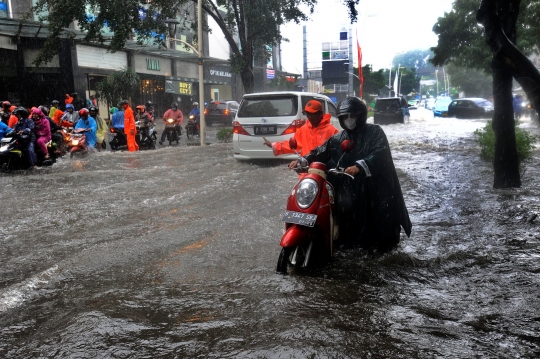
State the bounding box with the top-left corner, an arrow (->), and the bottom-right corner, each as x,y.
304,97 -> 412,252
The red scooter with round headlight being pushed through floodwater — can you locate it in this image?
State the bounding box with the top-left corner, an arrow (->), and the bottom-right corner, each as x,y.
276,138 -> 354,274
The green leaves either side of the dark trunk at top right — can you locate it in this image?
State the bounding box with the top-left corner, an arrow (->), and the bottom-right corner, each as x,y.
430,0 -> 540,73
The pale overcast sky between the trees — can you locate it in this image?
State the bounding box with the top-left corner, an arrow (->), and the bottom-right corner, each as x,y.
281,0 -> 453,74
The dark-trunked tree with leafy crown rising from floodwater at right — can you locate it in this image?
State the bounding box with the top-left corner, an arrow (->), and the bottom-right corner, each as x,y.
432,0 -> 540,188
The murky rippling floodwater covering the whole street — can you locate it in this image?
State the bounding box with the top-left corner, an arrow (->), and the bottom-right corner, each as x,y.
0,109 -> 540,358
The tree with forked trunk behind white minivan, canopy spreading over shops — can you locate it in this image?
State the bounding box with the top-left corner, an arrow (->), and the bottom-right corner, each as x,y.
33,0 -> 359,93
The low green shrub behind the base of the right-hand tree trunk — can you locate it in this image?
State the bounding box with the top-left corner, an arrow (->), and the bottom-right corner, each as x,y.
474,121 -> 539,161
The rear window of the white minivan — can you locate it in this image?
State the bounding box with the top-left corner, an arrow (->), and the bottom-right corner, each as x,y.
238,96 -> 298,117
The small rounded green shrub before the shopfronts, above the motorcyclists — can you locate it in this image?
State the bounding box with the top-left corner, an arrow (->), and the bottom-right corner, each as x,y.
97,67 -> 140,107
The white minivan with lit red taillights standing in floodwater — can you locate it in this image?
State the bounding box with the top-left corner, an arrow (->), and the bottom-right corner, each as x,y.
232,91 -> 341,160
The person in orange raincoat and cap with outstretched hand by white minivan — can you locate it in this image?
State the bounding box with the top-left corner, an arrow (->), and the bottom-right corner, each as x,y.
263,100 -> 339,168
